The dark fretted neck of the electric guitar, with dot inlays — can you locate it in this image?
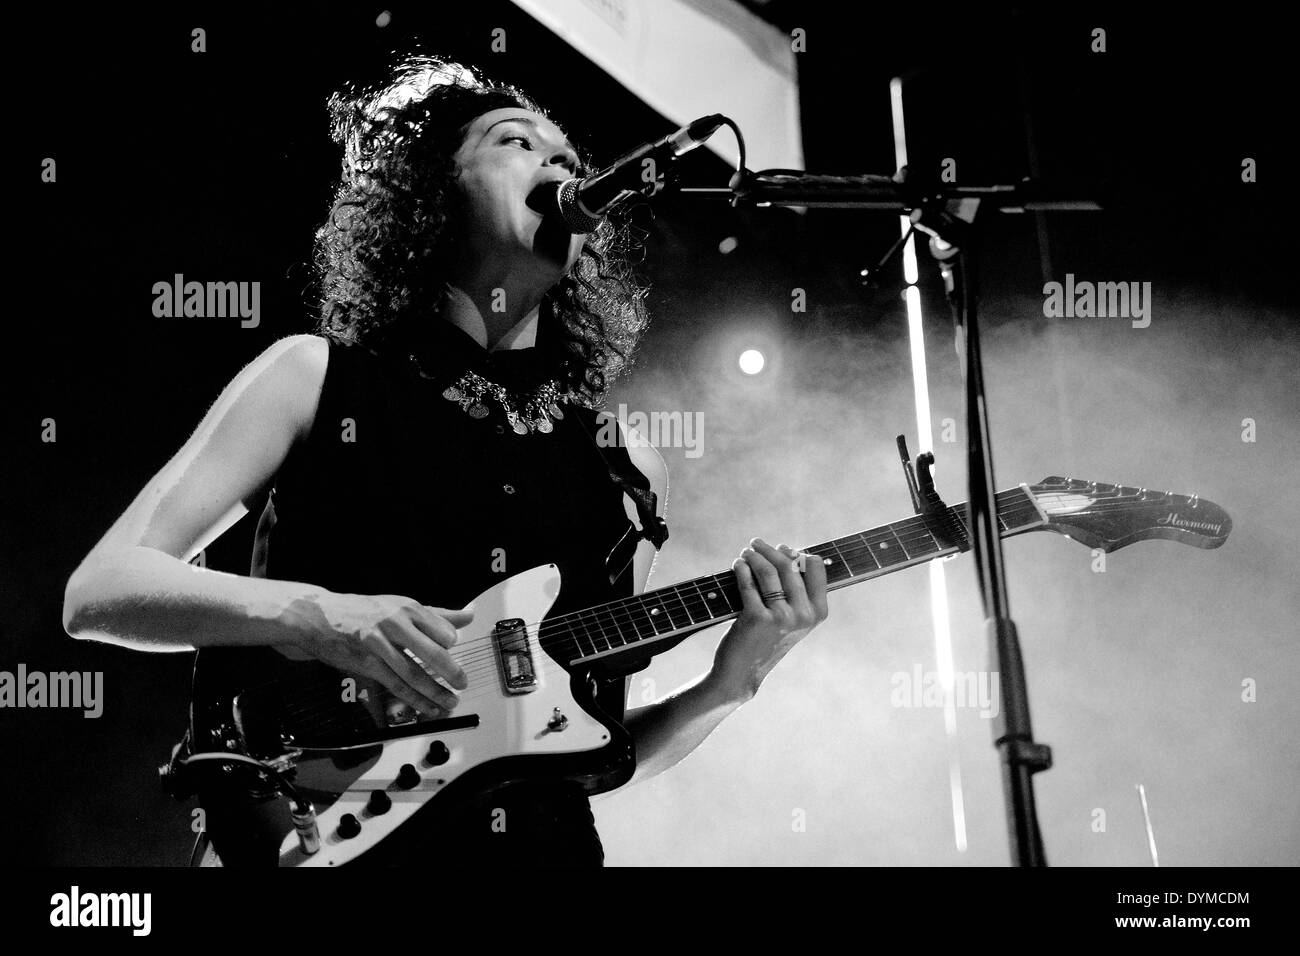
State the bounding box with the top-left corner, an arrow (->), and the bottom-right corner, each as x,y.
538,485 -> 1048,663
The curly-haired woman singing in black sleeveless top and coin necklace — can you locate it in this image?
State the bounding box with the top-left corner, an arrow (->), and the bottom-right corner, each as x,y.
64,57 -> 827,866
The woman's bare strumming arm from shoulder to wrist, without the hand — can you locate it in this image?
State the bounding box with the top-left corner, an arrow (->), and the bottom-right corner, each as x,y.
64,336 -> 328,650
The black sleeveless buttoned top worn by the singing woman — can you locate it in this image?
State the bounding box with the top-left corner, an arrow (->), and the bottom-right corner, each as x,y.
244,320 -> 666,865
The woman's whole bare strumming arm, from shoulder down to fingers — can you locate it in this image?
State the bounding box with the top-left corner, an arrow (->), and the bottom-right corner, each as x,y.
64,336 -> 472,713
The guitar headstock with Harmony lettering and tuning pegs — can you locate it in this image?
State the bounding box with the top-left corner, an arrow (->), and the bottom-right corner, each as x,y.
1027,476 -> 1232,551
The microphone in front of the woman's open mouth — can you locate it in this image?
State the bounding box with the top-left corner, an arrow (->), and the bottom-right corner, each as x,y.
546,113 -> 725,233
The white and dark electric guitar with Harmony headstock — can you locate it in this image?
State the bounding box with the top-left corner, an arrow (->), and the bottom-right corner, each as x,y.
180,477 -> 1232,866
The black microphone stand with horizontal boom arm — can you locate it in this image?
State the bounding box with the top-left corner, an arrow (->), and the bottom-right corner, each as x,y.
681,166 -> 1100,866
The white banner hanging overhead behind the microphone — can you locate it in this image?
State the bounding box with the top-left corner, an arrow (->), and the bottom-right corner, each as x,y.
514,0 -> 803,169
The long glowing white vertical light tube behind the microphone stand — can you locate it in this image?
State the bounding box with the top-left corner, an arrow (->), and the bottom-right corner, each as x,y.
889,77 -> 967,853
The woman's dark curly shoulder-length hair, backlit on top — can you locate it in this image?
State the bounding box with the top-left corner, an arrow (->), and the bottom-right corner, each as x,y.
313,55 -> 647,407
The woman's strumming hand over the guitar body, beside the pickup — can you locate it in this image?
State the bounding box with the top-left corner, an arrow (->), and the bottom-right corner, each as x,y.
273,592 -> 475,717
